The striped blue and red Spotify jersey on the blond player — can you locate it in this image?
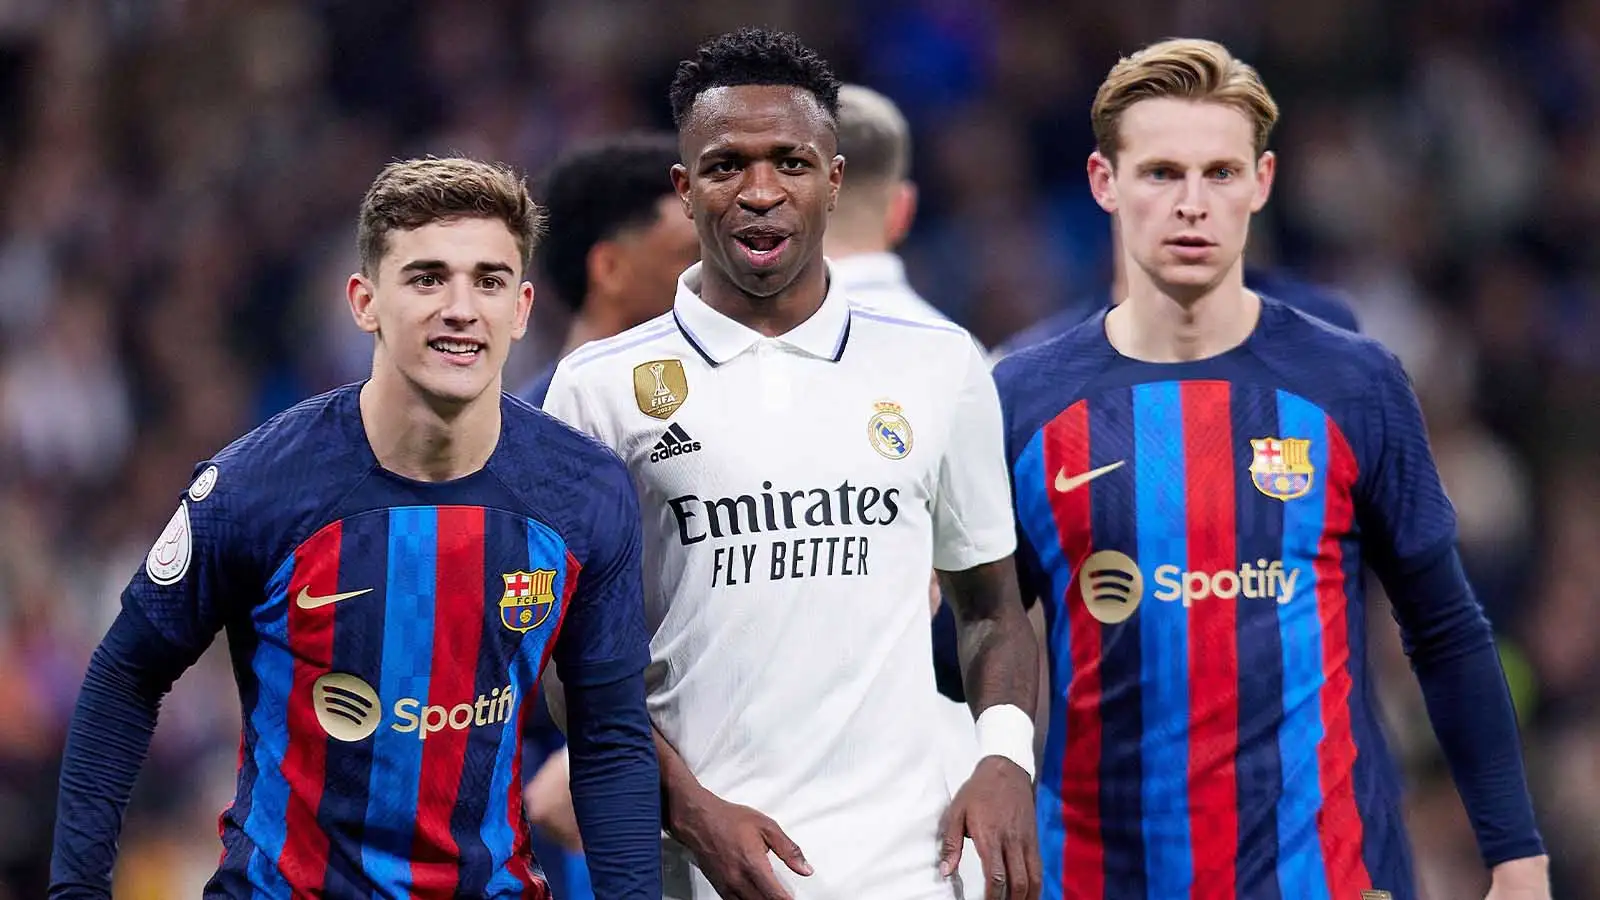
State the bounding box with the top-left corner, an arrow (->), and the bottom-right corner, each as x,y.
995,298 -> 1454,900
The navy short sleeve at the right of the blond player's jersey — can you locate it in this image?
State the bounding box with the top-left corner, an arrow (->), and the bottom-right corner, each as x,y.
1357,352 -> 1456,575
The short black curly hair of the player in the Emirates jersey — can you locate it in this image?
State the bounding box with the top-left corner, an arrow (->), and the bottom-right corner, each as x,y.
669,27 -> 838,128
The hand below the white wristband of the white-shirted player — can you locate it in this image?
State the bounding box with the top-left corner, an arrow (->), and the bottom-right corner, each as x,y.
939,756 -> 1043,900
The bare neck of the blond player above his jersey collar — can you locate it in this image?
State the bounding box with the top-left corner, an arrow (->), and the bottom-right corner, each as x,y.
1106,279 -> 1261,362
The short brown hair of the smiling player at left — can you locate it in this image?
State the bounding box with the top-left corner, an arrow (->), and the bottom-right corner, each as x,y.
355,157 -> 544,275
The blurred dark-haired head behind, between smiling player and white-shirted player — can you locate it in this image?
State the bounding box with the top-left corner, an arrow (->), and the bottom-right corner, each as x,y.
517,133 -> 699,405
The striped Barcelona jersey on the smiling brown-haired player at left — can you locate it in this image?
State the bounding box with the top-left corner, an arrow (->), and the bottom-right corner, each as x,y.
123,386 -> 654,898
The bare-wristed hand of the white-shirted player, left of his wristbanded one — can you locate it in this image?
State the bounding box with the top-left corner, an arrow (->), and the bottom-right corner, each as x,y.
672,790 -> 811,900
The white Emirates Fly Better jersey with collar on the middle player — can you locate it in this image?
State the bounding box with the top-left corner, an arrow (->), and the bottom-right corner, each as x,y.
544,266 -> 1016,900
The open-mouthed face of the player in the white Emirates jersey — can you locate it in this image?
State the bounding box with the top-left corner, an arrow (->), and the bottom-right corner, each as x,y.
672,85 -> 845,298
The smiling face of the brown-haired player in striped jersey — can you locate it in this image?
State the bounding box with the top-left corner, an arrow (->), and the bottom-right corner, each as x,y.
347,216 -> 533,407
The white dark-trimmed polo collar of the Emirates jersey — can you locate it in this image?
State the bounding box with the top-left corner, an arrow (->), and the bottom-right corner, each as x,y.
672,263 -> 850,365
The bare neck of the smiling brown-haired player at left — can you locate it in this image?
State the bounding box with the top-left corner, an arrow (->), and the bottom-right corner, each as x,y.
362,372 -> 501,482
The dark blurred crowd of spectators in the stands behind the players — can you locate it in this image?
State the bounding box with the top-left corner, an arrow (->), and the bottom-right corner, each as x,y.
0,0 -> 1600,900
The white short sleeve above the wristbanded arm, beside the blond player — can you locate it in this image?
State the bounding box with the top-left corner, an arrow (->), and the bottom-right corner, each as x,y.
933,336 -> 1016,572
